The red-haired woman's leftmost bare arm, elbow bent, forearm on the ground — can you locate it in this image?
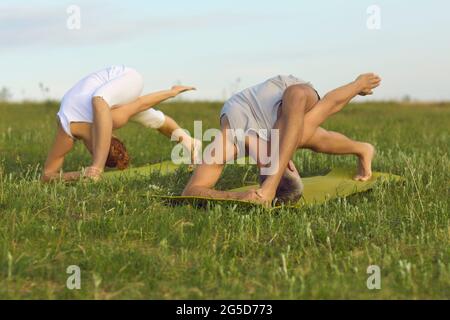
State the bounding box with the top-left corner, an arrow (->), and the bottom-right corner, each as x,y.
41,123 -> 79,182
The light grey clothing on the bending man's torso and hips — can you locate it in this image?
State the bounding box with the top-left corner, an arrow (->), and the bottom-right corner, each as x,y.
220,75 -> 314,150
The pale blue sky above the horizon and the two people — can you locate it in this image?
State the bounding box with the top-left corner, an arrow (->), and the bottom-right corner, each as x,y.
0,0 -> 450,100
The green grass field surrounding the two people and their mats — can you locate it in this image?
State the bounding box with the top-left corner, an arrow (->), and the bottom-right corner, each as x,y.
0,102 -> 450,299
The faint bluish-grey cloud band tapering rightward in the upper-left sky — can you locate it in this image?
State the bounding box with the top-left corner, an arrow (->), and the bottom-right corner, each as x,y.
0,4 -> 273,49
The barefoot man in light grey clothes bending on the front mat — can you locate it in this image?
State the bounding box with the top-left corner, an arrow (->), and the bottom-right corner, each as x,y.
183,73 -> 381,205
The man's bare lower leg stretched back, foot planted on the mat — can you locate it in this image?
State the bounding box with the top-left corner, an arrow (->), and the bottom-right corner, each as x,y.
301,129 -> 375,181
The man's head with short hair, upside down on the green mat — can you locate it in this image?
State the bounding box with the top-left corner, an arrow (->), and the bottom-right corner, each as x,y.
260,161 -> 304,203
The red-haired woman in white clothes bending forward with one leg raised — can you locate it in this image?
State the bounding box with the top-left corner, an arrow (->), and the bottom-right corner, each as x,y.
42,66 -> 200,182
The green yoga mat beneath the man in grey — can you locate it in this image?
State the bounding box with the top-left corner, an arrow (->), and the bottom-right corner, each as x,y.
152,168 -> 402,208
